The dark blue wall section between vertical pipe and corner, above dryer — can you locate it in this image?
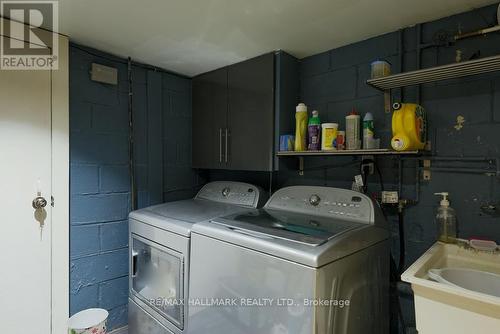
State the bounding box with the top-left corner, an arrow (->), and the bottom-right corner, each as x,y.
133,64 -> 205,208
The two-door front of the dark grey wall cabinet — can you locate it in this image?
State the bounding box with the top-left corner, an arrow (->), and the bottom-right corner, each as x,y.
193,53 -> 275,171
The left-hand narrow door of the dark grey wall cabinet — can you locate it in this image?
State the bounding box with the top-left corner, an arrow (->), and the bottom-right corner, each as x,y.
193,68 -> 227,168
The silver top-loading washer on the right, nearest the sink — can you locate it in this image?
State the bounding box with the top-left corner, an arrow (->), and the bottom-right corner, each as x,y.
187,186 -> 389,334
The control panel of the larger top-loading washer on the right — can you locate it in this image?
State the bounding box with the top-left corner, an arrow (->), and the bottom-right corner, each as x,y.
265,186 -> 374,223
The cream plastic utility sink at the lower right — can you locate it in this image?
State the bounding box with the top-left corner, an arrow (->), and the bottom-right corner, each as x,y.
401,242 -> 500,334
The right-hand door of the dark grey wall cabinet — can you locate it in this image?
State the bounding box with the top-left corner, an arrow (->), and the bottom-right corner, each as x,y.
227,53 -> 274,171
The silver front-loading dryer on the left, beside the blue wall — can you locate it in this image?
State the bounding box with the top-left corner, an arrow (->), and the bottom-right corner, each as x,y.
129,182 -> 267,334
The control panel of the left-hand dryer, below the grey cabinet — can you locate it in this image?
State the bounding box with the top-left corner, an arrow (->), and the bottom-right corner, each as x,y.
196,181 -> 265,208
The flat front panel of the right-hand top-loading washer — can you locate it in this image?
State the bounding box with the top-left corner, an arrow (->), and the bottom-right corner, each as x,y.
187,233 -> 316,334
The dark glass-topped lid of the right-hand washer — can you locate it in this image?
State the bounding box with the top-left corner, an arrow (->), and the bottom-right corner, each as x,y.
214,209 -> 364,246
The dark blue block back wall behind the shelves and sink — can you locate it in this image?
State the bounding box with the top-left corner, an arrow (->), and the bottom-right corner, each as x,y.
210,6 -> 500,332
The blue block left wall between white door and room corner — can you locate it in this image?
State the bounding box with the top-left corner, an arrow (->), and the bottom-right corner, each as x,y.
70,45 -> 203,329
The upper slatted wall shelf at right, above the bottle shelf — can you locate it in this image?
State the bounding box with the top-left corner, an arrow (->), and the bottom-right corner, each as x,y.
366,55 -> 500,91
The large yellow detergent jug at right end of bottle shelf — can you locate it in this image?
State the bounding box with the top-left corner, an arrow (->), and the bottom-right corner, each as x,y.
391,103 -> 427,151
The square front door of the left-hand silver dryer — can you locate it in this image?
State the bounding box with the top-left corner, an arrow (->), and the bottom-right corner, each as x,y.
130,234 -> 184,329
